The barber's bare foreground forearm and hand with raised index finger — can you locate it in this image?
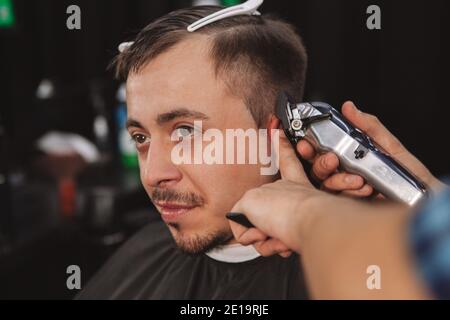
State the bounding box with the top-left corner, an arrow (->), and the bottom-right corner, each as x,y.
230,134 -> 428,299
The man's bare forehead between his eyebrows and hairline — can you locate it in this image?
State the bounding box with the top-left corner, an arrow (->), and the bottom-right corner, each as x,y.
127,36 -> 227,119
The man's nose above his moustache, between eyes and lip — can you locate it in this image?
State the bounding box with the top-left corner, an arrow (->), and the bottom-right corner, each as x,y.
141,141 -> 182,188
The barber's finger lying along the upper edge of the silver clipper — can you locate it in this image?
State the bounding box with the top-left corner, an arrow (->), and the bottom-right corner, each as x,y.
342,101 -> 406,154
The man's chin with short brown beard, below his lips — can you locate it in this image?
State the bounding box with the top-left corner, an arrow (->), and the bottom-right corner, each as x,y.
169,224 -> 233,255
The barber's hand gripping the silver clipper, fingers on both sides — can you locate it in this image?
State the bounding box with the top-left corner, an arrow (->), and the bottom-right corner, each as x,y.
297,101 -> 442,197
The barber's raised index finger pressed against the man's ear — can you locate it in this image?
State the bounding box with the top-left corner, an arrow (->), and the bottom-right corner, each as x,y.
279,130 -> 311,185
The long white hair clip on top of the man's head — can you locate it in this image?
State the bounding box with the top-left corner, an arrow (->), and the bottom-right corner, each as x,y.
187,0 -> 264,32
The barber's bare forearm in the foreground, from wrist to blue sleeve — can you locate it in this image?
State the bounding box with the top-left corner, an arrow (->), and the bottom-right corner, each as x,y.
298,196 -> 427,299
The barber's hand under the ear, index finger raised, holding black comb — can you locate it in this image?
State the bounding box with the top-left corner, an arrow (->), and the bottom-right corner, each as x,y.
230,131 -> 326,257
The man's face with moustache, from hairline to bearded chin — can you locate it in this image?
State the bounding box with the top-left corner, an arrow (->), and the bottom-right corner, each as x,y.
127,36 -> 271,253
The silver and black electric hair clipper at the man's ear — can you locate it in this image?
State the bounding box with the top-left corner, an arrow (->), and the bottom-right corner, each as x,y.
276,93 -> 427,206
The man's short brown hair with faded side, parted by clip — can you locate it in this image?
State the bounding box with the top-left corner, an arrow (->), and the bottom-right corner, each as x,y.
113,6 -> 307,127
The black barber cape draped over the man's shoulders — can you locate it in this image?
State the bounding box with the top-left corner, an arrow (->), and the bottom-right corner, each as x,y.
77,222 -> 307,299
